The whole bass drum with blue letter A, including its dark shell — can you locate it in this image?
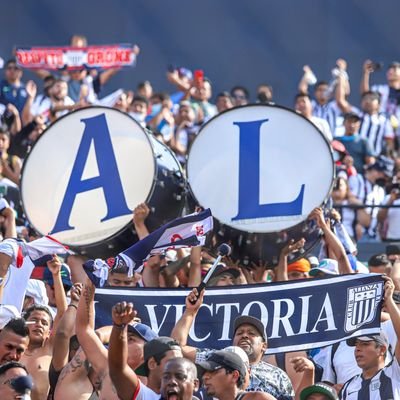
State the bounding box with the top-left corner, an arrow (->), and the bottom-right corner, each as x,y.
21,107 -> 185,257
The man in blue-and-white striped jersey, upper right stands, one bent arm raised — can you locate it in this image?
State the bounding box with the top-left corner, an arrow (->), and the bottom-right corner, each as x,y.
336,69 -> 395,156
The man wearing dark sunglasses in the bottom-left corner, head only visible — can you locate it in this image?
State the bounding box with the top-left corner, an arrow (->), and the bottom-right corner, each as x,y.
0,361 -> 33,400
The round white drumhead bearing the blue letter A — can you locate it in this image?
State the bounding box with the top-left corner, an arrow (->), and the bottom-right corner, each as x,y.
21,107 -> 156,246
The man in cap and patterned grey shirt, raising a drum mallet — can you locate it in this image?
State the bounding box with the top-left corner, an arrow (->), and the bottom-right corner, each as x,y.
171,289 -> 294,400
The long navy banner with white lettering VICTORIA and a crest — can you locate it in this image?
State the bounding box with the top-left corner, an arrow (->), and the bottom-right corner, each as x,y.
96,274 -> 383,353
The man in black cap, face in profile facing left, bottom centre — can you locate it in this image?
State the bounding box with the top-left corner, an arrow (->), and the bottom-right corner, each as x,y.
197,350 -> 275,400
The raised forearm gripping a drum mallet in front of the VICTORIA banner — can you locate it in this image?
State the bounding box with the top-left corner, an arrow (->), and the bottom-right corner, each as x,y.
171,288 -> 204,362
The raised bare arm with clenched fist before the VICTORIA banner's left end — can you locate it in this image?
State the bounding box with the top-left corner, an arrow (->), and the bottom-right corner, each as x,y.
108,301 -> 140,400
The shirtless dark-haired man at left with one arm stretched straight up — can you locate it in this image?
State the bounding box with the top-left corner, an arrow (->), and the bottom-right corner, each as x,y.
21,256 -> 67,400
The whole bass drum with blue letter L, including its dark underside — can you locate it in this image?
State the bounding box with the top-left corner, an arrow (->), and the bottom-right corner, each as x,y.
187,104 -> 334,265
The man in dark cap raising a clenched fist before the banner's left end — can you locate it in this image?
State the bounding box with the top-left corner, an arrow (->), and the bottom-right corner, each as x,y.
108,302 -> 182,400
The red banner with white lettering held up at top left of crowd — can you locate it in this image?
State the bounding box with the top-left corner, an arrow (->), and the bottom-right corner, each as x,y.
16,44 -> 136,70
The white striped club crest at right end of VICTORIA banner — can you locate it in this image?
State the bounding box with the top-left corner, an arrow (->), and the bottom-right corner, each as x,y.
344,283 -> 383,332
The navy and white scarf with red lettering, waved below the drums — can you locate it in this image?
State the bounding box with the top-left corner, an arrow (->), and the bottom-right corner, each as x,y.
83,209 -> 213,287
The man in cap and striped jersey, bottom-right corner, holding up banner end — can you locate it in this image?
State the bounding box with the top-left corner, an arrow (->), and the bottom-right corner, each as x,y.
339,277 -> 400,400
